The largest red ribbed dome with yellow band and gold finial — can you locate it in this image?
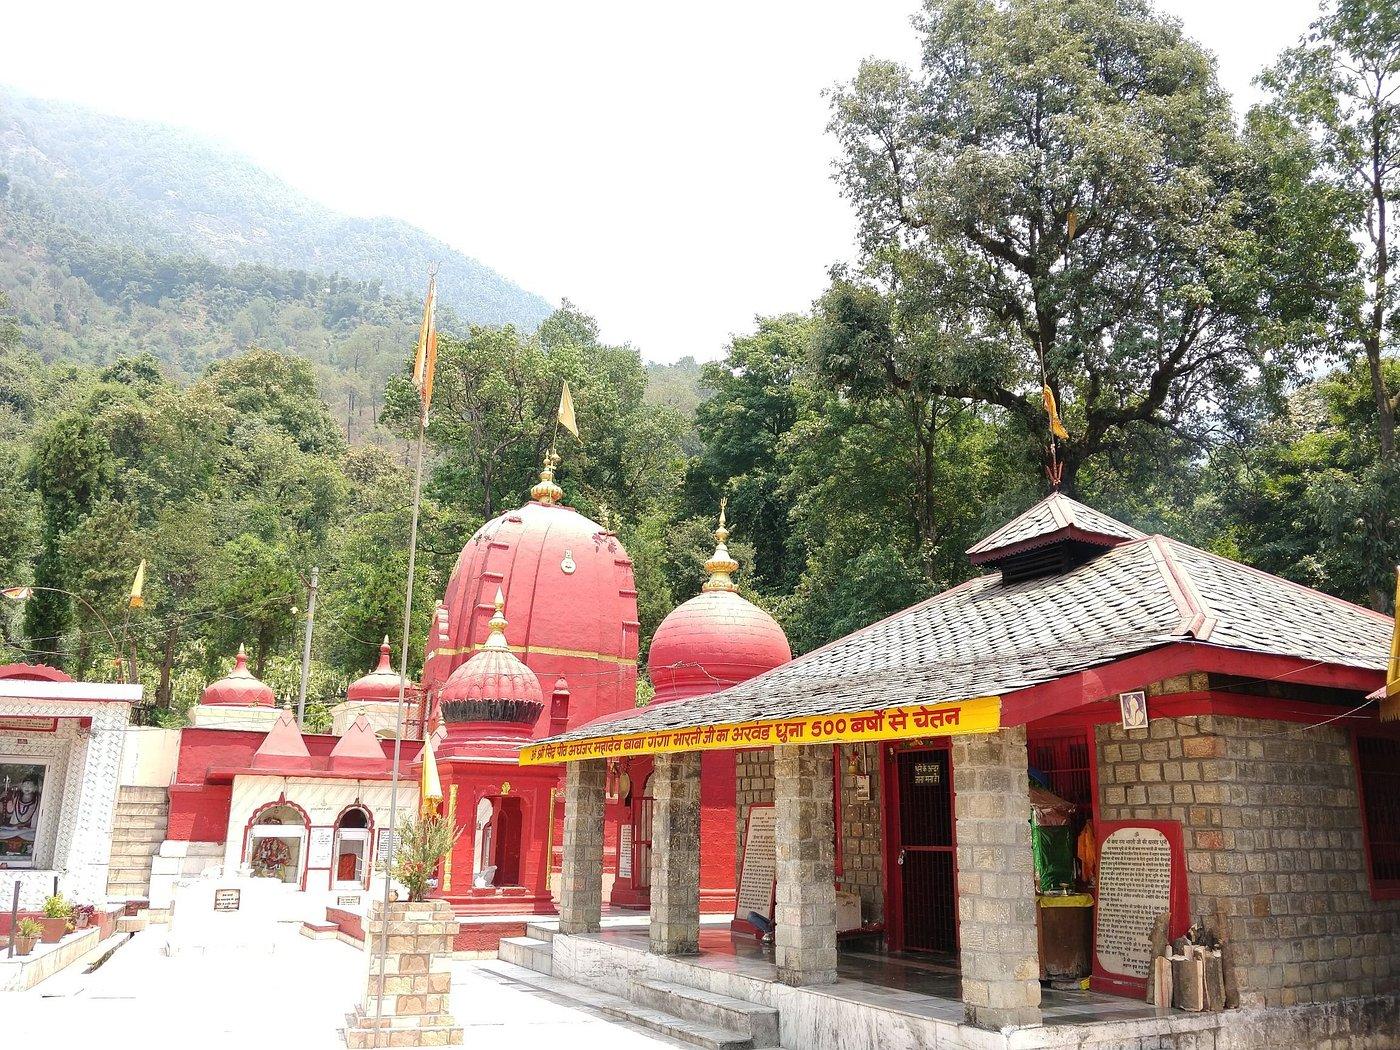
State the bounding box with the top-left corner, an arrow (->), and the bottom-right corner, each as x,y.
423,454 -> 640,736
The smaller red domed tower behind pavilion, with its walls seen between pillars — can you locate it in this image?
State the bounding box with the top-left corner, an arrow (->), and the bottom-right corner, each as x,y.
612,504 -> 792,911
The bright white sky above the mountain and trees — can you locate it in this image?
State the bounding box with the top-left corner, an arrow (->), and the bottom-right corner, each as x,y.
0,0 -> 1316,361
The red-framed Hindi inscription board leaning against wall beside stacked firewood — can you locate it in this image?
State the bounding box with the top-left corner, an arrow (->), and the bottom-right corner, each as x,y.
1091,820 -> 1190,997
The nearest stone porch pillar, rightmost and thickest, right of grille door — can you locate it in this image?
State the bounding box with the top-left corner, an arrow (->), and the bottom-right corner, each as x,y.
952,725 -> 1040,1029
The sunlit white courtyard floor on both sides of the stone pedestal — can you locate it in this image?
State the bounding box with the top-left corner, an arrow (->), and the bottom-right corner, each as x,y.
0,925 -> 678,1050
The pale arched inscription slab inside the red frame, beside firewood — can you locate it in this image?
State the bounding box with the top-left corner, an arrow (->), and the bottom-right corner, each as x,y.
1093,827 -> 1172,979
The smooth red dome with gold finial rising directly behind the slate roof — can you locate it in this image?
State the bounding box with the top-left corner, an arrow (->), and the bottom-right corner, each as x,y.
647,504 -> 792,703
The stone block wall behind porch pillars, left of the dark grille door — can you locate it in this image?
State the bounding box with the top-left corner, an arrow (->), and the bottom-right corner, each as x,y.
734,743 -> 885,923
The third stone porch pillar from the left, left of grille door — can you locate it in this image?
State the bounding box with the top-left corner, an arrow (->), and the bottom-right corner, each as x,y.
773,745 -> 836,984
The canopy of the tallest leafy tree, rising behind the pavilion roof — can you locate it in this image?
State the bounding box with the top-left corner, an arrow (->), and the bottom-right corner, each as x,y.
823,0 -> 1310,490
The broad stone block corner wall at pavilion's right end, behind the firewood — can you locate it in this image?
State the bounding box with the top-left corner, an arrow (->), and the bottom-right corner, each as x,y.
1096,715 -> 1400,1007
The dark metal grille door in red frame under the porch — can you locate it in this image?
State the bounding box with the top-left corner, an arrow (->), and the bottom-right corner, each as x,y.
896,749 -> 958,955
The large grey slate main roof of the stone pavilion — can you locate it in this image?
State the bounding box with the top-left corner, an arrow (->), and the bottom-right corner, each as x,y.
540,497 -> 1392,741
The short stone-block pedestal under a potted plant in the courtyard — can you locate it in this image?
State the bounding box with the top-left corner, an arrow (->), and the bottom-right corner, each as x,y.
344,900 -> 462,1050
